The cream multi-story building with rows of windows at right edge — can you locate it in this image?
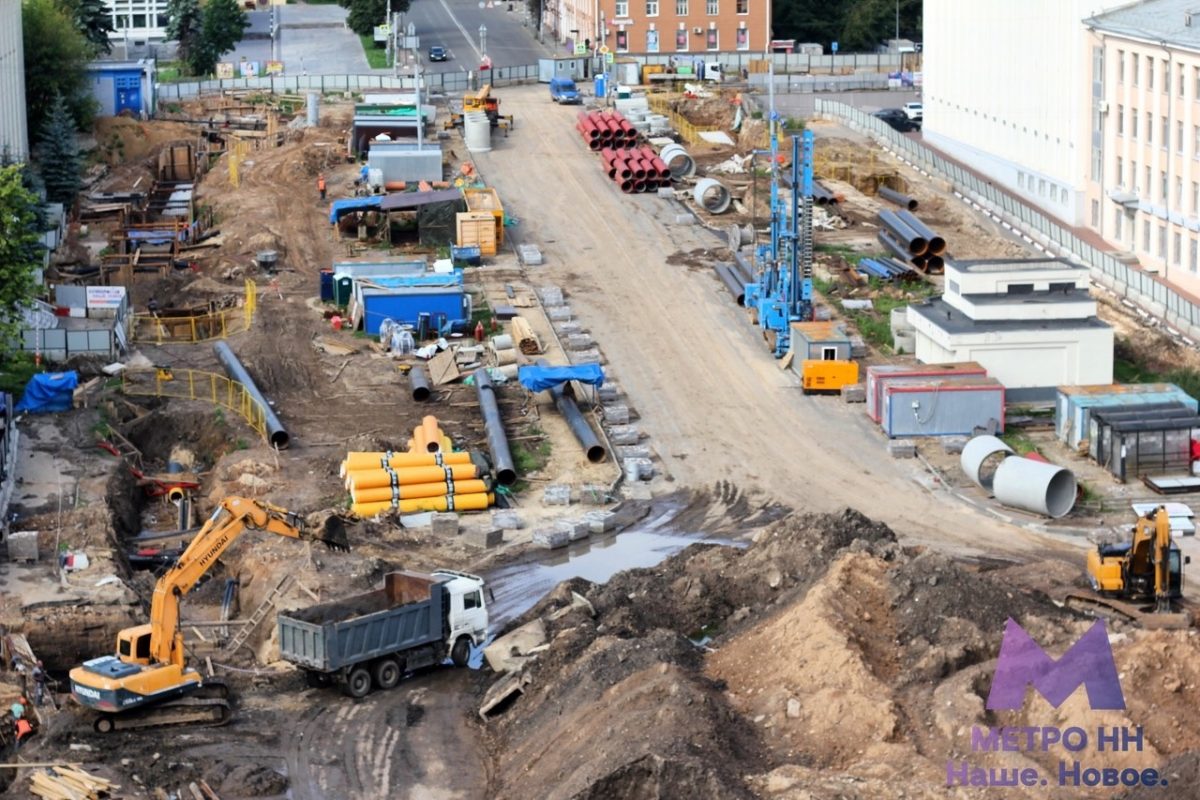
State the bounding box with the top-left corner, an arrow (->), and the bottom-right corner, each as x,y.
1079,0 -> 1200,295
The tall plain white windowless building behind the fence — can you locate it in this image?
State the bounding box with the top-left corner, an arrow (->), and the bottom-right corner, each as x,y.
922,0 -> 1128,224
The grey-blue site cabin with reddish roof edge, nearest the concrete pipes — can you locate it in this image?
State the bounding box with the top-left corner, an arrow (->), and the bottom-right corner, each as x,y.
881,375 -> 1004,439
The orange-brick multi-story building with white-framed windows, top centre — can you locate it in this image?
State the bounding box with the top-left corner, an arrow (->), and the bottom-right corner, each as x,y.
590,0 -> 770,56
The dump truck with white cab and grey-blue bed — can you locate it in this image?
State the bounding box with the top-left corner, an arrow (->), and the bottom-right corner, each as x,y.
277,570 -> 487,698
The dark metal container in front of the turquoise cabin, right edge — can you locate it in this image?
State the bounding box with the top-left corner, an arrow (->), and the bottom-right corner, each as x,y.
1088,403 -> 1200,483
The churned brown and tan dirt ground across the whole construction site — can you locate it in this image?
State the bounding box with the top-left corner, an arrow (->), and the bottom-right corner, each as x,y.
7,86 -> 1200,800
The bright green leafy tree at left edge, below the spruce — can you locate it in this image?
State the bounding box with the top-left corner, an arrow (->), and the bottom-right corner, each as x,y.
0,164 -> 42,342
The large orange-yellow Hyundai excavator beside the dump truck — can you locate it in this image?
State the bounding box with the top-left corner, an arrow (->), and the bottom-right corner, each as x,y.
71,497 -> 349,733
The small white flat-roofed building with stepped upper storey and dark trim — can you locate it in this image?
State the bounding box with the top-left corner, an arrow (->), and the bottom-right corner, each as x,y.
908,258 -> 1112,401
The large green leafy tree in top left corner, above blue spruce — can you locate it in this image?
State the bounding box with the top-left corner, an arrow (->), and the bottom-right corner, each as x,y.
20,0 -> 96,139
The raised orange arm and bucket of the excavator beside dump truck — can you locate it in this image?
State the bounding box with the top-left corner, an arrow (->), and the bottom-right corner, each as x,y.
150,497 -> 349,667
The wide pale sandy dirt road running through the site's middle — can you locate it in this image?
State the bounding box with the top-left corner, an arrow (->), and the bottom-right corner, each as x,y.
476,88 -> 1069,557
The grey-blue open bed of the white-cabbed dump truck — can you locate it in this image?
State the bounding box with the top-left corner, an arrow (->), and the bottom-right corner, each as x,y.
278,572 -> 446,672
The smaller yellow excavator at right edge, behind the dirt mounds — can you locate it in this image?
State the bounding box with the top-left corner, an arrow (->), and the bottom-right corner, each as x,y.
1067,506 -> 1192,628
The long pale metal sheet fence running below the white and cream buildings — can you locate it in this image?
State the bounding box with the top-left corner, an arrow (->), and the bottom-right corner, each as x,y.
816,98 -> 1200,338
